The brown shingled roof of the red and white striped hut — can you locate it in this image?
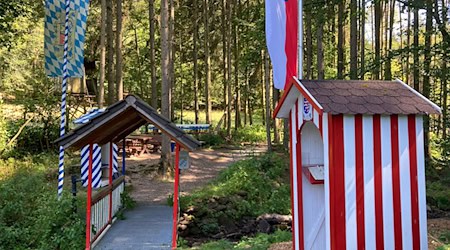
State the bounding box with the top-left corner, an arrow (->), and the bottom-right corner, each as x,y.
276,77 -> 441,117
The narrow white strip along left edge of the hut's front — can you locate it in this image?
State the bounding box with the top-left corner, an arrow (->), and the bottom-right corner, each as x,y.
291,105 -> 300,250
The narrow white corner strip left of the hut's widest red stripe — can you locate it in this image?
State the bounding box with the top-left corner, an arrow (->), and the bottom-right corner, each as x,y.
322,113 -> 331,250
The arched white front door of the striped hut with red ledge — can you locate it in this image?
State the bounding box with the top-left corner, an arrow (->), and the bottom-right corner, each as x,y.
298,122 -> 326,250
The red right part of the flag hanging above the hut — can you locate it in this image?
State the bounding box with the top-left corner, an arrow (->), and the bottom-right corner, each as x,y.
284,0 -> 298,89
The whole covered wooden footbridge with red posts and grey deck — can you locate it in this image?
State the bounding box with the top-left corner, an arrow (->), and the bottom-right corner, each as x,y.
56,95 -> 200,249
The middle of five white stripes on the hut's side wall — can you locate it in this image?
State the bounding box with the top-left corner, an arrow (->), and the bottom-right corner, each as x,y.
380,116 -> 395,249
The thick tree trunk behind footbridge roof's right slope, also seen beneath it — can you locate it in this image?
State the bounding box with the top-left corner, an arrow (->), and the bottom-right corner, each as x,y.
161,0 -> 171,172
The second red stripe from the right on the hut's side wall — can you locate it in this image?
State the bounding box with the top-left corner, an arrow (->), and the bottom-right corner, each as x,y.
391,115 -> 403,249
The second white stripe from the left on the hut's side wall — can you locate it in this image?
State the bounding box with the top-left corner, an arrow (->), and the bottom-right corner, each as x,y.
363,116 -> 376,250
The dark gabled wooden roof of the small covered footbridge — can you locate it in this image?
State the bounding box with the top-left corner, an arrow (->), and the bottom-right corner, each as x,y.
55,95 -> 200,150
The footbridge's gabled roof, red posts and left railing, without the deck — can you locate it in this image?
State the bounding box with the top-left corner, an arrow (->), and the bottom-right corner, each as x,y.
56,95 -> 200,249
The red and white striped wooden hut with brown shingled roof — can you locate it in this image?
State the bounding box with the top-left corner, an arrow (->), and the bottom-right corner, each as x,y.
274,79 -> 441,250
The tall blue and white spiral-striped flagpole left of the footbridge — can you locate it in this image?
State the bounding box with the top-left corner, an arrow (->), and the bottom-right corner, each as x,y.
58,0 -> 70,198
